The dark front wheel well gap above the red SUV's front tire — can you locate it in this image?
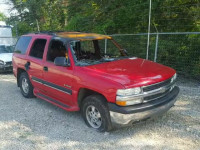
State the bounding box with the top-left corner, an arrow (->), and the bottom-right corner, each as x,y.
78,88 -> 106,107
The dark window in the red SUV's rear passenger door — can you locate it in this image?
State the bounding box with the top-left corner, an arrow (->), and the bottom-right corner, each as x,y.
30,39 -> 47,59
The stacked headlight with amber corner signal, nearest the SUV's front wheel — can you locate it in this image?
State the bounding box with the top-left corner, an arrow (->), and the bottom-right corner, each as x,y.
116,87 -> 143,106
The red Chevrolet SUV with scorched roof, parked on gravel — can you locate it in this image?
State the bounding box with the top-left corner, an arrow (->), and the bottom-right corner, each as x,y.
13,32 -> 179,131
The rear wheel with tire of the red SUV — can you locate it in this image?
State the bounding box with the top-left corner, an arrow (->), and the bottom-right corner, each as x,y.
19,72 -> 34,98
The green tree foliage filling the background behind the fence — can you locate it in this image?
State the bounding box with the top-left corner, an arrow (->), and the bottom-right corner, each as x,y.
4,0 -> 200,76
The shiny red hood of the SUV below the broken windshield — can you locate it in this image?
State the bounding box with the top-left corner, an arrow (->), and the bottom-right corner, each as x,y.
86,58 -> 176,88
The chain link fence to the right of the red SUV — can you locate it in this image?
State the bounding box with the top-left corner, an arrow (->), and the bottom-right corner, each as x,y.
112,32 -> 200,93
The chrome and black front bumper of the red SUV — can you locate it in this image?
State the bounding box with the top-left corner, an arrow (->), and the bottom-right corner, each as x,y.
108,86 -> 179,126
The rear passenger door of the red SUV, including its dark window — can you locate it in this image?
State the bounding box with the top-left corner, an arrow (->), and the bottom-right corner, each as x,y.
25,38 -> 48,92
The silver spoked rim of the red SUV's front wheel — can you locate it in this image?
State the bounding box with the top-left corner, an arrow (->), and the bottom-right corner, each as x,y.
86,105 -> 102,129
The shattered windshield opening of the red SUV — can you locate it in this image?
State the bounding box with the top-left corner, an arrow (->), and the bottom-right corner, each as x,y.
70,39 -> 128,66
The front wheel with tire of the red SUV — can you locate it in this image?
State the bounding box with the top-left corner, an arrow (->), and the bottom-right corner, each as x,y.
81,95 -> 112,132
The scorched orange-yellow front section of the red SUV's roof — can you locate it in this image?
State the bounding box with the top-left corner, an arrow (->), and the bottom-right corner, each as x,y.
55,32 -> 111,41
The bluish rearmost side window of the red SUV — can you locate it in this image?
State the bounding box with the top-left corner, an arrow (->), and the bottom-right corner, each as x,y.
14,36 -> 31,54
